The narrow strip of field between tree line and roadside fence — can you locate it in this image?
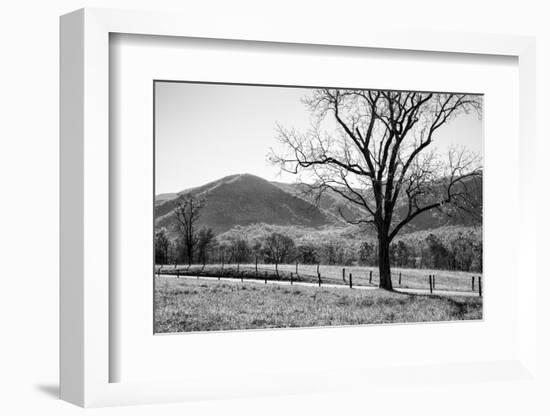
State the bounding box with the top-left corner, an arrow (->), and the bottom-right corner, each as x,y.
157,264 -> 480,292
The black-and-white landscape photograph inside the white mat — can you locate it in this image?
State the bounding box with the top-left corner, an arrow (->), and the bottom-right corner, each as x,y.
153,80 -> 484,333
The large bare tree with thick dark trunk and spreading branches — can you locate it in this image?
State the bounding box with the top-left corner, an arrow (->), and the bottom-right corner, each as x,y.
270,89 -> 481,290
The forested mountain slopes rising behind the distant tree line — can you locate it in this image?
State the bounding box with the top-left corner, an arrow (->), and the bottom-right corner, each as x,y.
155,174 -> 482,234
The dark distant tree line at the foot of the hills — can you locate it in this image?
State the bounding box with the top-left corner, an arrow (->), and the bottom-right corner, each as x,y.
155,221 -> 483,272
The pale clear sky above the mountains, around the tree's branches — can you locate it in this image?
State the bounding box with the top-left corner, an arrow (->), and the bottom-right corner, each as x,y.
155,82 -> 482,194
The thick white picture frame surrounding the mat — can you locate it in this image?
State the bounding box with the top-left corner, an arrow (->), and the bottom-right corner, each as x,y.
60,9 -> 538,407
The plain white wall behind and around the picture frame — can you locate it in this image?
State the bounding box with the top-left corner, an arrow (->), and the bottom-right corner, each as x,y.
0,0 -> 550,415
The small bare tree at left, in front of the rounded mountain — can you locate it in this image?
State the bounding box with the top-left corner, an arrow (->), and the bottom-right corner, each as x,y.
174,195 -> 204,266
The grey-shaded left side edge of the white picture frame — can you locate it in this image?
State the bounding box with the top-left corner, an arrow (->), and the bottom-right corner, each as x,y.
59,9 -> 85,406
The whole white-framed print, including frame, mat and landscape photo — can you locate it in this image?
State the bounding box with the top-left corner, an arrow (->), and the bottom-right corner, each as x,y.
61,9 -> 537,406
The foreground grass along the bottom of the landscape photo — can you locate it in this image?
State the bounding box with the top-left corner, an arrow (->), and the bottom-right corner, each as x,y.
155,276 -> 482,333
